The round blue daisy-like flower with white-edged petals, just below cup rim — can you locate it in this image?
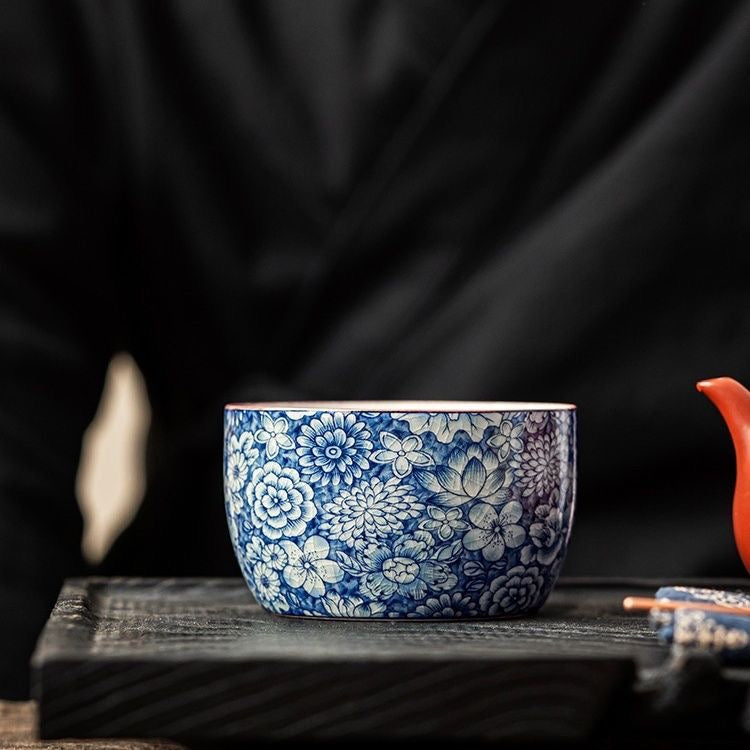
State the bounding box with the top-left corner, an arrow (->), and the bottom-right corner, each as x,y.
297,411 -> 372,486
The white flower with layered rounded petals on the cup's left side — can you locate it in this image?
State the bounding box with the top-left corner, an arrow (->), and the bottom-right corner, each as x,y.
246,461 -> 317,539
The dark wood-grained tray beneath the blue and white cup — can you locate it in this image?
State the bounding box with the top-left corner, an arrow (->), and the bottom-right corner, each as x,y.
33,578 -> 747,743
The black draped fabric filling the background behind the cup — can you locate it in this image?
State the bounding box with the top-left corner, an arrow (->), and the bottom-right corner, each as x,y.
0,0 -> 750,696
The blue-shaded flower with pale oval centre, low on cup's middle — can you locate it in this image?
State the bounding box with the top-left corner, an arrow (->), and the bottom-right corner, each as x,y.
360,531 -> 458,600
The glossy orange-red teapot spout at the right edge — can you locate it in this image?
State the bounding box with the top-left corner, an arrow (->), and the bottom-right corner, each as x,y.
696,378 -> 750,573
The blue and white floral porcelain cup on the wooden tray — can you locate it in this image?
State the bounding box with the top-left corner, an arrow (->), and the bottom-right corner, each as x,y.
224,401 -> 576,619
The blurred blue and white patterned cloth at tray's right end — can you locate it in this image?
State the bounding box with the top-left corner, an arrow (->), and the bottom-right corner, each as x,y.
649,586 -> 750,664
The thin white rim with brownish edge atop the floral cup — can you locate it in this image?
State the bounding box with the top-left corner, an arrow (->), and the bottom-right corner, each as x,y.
224,400 -> 576,414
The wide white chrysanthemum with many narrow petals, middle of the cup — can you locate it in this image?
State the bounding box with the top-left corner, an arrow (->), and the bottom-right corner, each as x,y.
320,477 -> 424,547
